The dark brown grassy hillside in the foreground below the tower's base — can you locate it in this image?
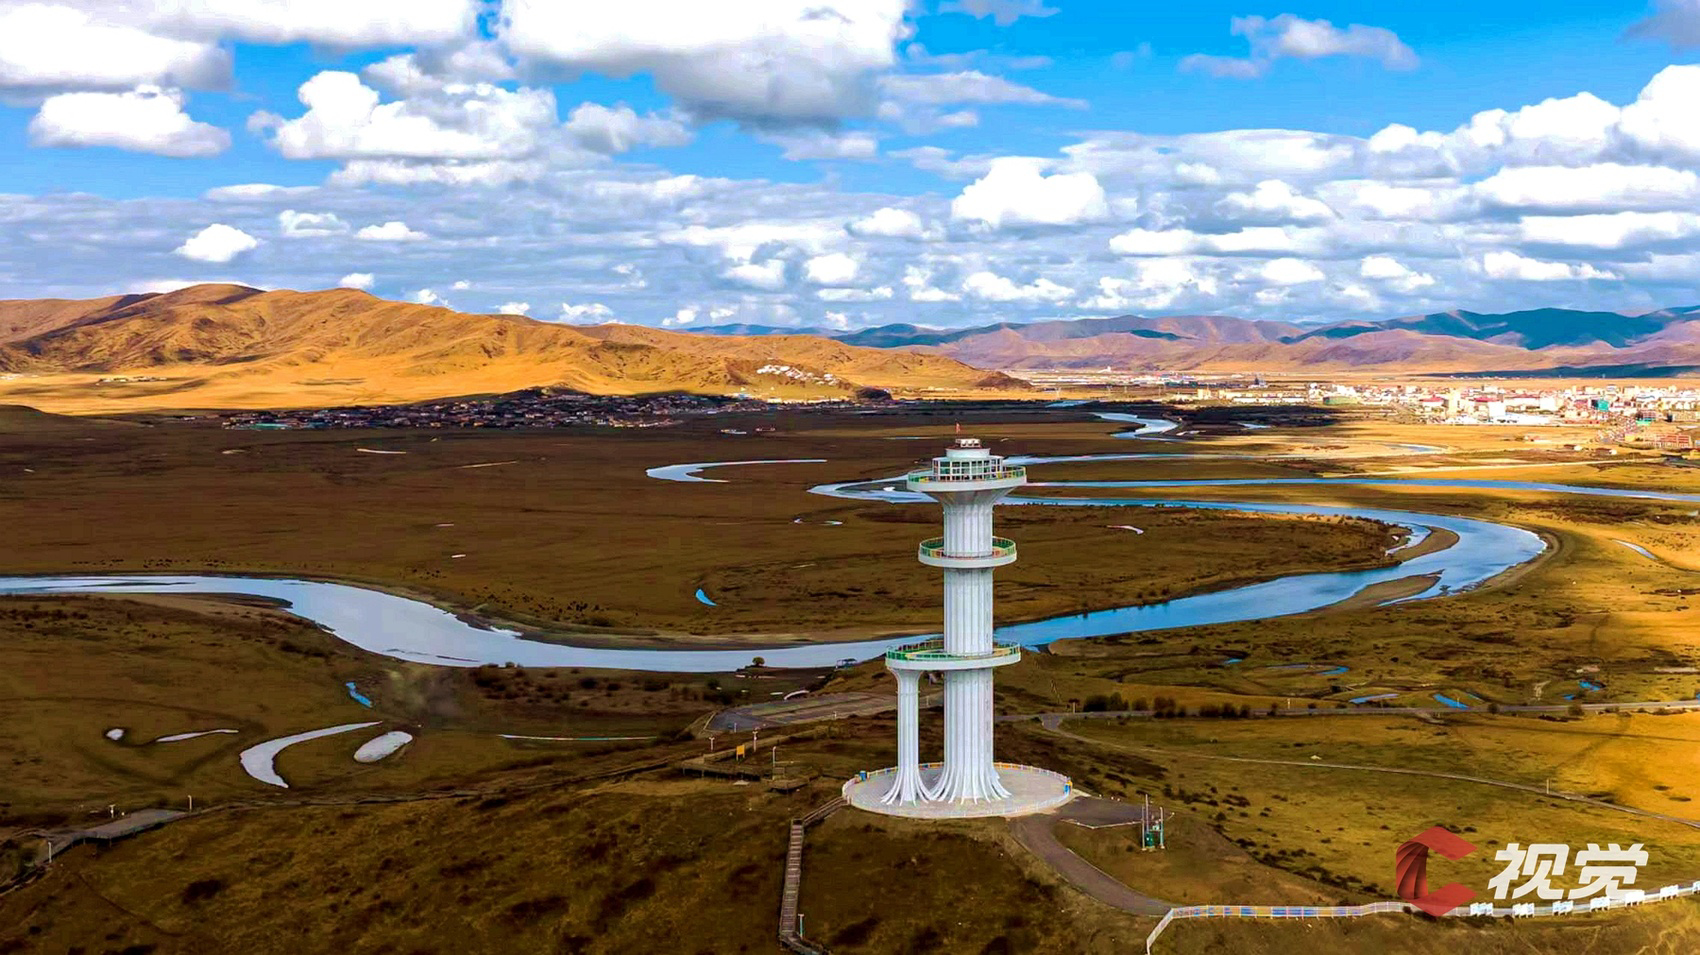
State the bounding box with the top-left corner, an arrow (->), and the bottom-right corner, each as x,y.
0,764 -> 1125,955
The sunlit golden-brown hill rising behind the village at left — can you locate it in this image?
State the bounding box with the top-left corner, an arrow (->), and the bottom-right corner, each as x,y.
0,285 -> 1015,411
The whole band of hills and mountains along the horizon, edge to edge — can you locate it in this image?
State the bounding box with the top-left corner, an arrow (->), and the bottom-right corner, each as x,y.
0,284 -> 1700,411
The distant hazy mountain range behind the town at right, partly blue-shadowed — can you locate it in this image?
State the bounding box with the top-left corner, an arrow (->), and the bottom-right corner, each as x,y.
695,306 -> 1700,376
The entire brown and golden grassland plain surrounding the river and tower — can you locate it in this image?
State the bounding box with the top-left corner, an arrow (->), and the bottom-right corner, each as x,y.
0,399 -> 1700,955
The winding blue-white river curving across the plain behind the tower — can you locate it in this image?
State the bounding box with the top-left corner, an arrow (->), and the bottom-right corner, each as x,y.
0,433 -> 1700,673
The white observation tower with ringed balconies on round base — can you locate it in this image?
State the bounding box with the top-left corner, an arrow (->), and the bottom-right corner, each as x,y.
845,438 -> 1071,816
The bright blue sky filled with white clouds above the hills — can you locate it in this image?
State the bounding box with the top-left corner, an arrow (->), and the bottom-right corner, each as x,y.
0,0 -> 1700,328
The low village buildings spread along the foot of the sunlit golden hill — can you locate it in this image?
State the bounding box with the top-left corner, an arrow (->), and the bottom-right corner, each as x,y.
224,389 -> 850,430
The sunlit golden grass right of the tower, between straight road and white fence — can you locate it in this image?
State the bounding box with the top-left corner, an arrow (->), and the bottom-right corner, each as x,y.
1064,717 -> 1700,904
